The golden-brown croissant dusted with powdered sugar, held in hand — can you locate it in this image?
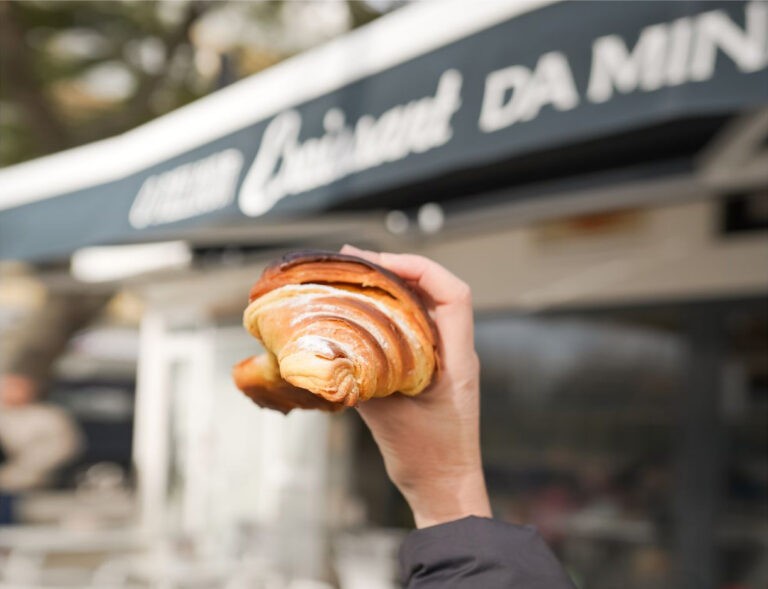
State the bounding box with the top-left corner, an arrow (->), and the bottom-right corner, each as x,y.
233,251 -> 438,413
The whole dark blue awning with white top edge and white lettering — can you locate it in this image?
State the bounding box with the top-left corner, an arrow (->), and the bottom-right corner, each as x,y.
0,0 -> 768,260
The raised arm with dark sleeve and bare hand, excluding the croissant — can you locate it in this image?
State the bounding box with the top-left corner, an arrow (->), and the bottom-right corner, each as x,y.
342,246 -> 573,589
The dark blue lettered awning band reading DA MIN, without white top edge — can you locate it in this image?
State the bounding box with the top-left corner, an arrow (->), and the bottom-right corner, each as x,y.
0,2 -> 768,259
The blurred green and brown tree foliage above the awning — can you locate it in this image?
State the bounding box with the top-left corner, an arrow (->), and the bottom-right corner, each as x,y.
0,0 -> 384,166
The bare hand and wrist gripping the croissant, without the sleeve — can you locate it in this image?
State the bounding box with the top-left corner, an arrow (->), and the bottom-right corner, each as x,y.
341,245 -> 491,528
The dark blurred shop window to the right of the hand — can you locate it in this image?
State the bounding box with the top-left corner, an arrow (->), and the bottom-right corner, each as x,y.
477,301 -> 768,589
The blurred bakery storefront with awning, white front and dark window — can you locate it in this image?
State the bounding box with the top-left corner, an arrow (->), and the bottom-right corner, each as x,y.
0,1 -> 768,589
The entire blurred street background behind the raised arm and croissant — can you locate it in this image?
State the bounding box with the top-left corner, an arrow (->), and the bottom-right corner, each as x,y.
0,0 -> 768,589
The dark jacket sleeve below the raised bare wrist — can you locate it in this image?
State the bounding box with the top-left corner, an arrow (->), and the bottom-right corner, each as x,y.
400,517 -> 574,589
